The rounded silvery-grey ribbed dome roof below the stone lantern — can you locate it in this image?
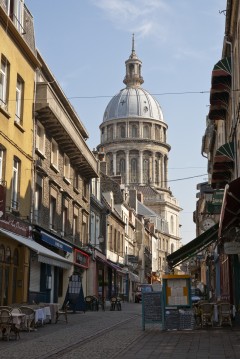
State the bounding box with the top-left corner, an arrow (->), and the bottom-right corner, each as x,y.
103,86 -> 164,122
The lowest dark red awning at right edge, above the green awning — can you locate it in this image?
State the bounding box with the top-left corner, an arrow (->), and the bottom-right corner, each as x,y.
219,178 -> 240,237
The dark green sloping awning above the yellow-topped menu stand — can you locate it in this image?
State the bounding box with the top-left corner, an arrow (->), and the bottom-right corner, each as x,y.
167,223 -> 219,267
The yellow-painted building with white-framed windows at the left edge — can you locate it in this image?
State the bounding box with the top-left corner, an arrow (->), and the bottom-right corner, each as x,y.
0,0 -> 39,305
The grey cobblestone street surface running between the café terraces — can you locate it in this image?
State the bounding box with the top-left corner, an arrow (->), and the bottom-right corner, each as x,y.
0,303 -> 240,359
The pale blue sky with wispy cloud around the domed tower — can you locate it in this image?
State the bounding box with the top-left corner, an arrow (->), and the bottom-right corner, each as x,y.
25,0 -> 227,244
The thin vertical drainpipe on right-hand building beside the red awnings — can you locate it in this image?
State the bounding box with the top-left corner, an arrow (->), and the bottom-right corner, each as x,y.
225,37 -> 238,179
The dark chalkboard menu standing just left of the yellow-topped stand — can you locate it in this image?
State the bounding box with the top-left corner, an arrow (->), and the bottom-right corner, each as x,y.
142,292 -> 163,330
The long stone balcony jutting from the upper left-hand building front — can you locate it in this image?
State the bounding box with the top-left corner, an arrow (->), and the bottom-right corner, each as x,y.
35,82 -> 98,178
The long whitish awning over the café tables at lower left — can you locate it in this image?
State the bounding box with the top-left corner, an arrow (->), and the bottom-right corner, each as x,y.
0,228 -> 72,269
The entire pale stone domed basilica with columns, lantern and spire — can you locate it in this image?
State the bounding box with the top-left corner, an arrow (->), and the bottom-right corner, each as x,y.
98,36 -> 181,276
